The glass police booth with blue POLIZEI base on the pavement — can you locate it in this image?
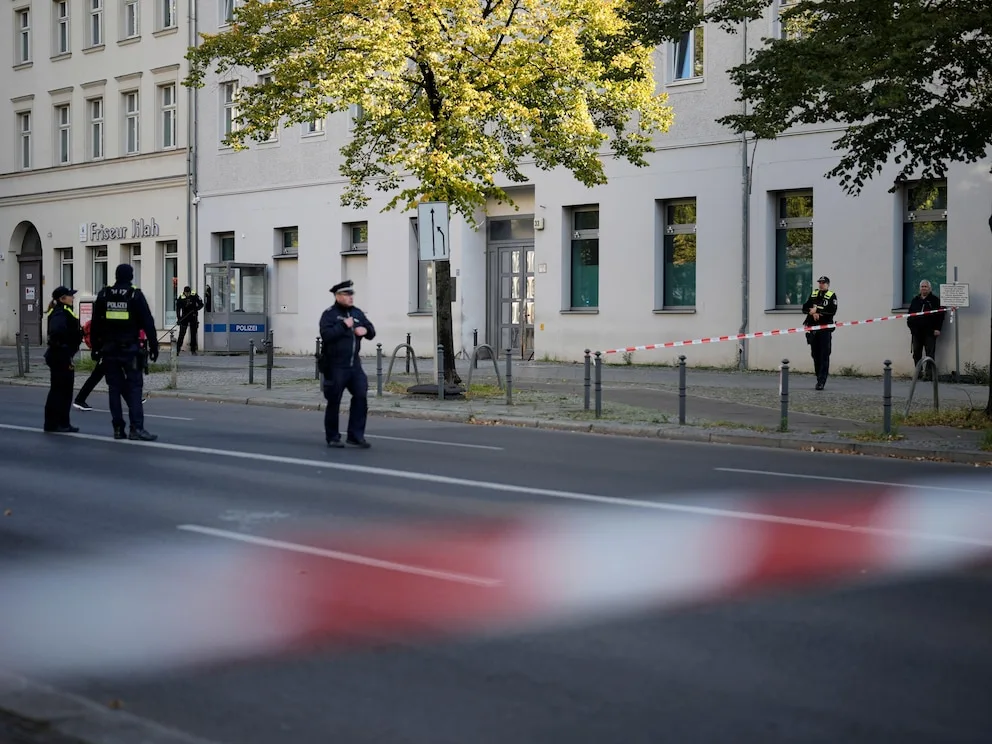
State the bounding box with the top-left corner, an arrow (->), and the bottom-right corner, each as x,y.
202,261 -> 269,354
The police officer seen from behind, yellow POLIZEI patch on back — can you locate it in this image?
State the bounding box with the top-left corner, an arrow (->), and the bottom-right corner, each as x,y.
90,264 -> 158,442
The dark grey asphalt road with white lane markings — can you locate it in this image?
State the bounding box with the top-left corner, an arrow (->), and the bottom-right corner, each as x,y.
0,386 -> 992,744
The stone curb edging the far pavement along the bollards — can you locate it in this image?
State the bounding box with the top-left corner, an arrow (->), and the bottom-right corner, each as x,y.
0,379 -> 992,467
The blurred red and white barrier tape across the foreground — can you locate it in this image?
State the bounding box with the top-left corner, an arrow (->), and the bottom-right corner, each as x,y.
0,478 -> 992,676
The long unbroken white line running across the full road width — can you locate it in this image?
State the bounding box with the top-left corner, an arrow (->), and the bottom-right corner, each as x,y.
0,424 -> 992,547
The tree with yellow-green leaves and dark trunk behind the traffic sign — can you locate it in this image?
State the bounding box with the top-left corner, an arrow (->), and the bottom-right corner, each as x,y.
185,0 -> 672,383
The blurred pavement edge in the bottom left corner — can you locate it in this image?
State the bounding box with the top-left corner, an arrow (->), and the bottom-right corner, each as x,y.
0,671 -> 218,744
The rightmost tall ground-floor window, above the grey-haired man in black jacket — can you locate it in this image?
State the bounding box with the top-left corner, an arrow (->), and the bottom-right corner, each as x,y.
902,182 -> 947,307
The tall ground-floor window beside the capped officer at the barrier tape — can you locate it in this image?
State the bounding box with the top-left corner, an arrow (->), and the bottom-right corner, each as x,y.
775,191 -> 813,308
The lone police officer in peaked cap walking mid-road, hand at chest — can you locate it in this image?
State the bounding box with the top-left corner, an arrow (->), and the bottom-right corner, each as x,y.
320,279 -> 375,449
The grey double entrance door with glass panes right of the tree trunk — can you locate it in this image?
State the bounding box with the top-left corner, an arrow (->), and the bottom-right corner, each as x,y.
498,245 -> 534,359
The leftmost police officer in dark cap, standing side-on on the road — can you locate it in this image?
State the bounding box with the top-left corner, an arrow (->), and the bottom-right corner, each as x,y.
45,287 -> 83,434
